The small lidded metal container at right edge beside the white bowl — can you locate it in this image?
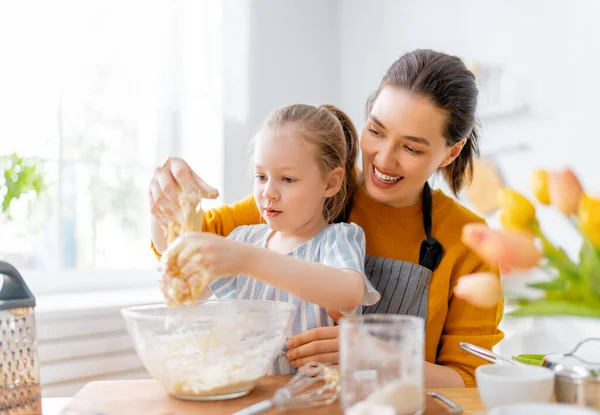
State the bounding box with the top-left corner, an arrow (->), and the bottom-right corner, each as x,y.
543,338 -> 600,410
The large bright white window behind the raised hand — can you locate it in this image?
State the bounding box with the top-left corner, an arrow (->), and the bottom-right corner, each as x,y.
0,0 -> 223,293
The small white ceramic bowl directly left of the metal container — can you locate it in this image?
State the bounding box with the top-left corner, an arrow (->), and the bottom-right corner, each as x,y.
475,364 -> 554,409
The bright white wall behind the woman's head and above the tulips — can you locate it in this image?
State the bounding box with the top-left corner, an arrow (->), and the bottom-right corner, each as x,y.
340,0 -> 600,255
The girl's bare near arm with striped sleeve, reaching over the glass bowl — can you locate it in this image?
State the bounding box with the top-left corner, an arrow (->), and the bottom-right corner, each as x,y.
177,224 -> 372,312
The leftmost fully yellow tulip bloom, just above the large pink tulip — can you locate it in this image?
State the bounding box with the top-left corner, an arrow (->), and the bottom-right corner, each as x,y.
498,188 -> 536,231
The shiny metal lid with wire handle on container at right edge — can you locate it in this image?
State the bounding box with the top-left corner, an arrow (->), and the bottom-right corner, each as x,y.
543,337 -> 600,382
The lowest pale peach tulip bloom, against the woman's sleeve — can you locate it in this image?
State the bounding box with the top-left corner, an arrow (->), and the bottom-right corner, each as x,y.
454,272 -> 502,308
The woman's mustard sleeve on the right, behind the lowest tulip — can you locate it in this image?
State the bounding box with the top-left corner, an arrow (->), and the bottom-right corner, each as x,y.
436,252 -> 504,387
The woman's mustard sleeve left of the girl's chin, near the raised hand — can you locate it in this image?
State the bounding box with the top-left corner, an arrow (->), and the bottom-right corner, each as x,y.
150,195 -> 261,259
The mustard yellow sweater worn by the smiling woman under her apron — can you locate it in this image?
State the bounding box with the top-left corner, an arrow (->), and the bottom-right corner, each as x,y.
152,186 -> 503,387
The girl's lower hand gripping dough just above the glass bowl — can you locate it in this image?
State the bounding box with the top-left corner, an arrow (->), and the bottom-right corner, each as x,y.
169,232 -> 252,278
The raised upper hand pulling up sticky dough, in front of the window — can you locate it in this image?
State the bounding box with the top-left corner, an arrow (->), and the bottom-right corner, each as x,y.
149,157 -> 219,253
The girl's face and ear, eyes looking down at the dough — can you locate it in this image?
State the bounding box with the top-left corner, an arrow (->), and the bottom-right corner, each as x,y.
254,129 -> 343,239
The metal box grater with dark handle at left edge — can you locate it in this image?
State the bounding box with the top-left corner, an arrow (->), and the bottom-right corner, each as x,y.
0,261 -> 42,415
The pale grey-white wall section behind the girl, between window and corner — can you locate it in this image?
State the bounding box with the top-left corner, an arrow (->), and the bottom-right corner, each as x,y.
222,0 -> 340,203
